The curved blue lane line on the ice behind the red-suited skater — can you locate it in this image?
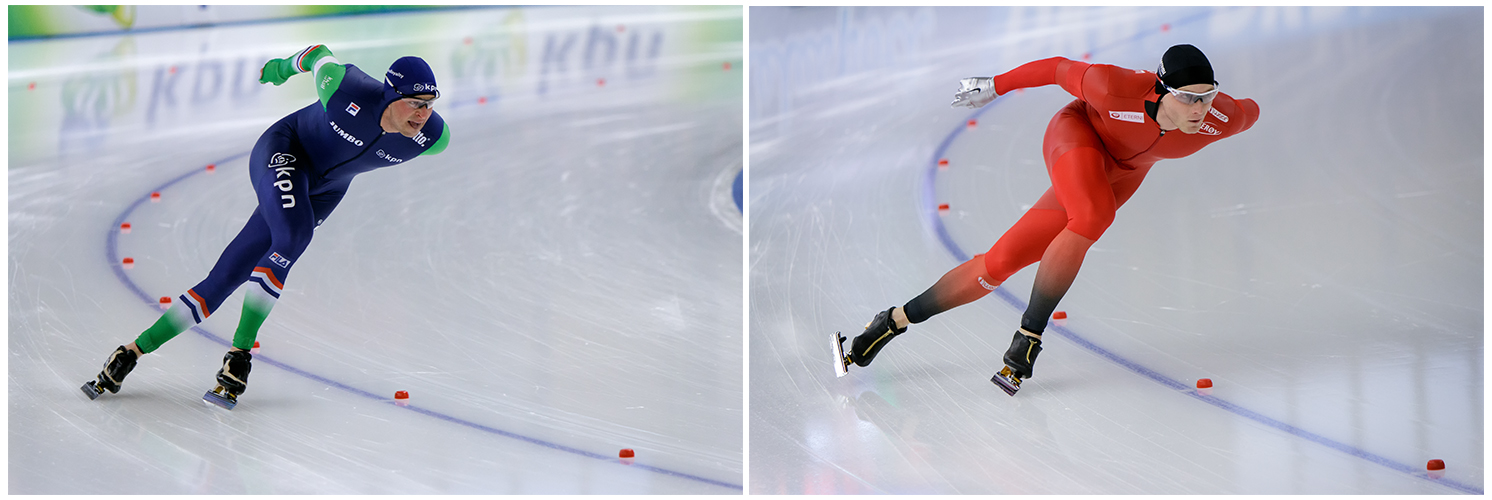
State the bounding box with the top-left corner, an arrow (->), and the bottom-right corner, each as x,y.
922,8 -> 1483,494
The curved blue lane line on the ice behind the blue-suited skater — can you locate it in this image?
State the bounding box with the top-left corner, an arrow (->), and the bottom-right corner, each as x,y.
106,152 -> 745,490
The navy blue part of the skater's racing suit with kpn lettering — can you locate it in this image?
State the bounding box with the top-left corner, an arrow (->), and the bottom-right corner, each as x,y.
182,64 -> 449,322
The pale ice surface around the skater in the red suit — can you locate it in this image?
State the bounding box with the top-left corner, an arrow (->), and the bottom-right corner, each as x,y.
747,7 -> 1485,494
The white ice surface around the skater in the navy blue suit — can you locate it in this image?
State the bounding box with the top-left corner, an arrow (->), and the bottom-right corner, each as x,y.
7,7 -> 745,494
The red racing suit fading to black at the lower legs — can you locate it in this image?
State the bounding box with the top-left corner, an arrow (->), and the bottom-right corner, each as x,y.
903,57 -> 1259,336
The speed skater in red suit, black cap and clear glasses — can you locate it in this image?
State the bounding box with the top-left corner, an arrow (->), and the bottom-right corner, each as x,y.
836,45 -> 1259,396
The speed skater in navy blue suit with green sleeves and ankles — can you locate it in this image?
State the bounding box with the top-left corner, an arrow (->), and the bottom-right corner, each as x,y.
82,45 -> 451,409
